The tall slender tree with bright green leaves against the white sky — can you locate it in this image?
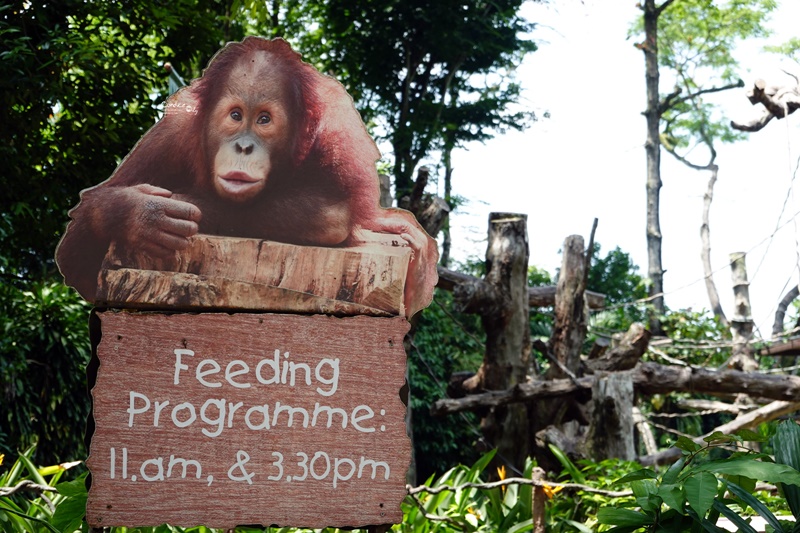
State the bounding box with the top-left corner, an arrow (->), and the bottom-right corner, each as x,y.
634,0 -> 776,332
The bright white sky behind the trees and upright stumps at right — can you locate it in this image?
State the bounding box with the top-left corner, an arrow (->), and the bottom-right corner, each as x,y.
440,0 -> 800,339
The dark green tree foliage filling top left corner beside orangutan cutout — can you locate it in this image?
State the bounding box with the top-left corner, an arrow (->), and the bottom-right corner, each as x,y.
0,0 -> 237,279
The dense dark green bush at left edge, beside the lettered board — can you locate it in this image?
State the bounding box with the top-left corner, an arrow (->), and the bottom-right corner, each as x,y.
0,282 -> 90,463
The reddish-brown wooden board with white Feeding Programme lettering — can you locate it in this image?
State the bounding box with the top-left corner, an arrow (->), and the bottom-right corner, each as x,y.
87,312 -> 410,528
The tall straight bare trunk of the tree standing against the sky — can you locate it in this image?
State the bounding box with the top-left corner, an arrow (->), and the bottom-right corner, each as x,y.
641,0 -> 664,335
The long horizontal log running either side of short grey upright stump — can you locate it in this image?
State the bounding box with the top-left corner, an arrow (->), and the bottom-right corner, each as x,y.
431,363 -> 800,416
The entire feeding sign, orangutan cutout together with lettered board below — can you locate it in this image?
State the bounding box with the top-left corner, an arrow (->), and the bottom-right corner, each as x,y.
56,37 -> 438,528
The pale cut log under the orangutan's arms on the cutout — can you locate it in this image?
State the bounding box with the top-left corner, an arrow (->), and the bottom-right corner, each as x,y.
95,235 -> 411,316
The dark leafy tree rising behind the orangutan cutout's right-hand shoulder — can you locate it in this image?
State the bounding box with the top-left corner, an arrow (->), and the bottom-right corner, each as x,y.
321,0 -> 536,204
